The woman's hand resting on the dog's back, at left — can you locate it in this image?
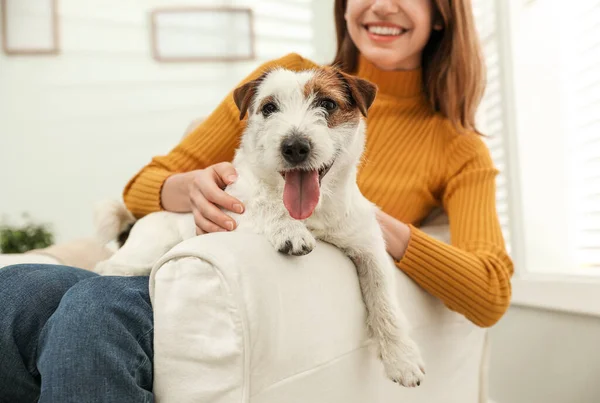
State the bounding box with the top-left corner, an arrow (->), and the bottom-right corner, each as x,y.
189,162 -> 244,235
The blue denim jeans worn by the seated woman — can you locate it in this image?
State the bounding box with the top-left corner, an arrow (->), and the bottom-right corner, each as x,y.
0,264 -> 153,403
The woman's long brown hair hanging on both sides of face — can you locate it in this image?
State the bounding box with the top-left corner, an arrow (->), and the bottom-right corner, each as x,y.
332,0 -> 485,132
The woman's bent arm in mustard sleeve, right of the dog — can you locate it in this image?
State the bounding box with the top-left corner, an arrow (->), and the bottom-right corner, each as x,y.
380,135 -> 513,327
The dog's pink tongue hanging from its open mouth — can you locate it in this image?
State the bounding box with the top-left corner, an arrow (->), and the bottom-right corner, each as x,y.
283,170 -> 320,220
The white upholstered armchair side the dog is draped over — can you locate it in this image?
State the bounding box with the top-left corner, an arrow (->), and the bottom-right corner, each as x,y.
150,216 -> 487,403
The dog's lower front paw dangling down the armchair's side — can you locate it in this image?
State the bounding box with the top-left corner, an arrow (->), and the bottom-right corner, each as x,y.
381,339 -> 425,388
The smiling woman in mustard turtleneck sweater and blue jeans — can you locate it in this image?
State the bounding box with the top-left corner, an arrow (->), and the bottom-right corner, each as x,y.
0,0 -> 513,402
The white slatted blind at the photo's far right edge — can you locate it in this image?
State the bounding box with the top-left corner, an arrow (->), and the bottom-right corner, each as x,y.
565,0 -> 600,269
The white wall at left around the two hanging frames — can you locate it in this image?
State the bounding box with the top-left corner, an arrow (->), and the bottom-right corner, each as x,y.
0,0 -> 318,242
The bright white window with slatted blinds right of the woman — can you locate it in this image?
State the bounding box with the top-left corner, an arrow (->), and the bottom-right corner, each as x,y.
472,0 -> 600,274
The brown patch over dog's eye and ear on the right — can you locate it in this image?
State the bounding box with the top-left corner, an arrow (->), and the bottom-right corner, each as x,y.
304,67 -> 377,127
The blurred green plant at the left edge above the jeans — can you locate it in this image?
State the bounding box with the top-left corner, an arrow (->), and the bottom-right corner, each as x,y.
0,214 -> 54,253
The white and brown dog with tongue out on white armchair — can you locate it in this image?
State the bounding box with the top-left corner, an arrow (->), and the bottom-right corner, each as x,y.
96,66 -> 425,387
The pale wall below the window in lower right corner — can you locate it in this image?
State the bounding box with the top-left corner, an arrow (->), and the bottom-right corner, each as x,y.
489,308 -> 600,403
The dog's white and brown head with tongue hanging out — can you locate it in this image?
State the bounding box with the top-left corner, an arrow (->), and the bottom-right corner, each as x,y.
233,67 -> 377,219
